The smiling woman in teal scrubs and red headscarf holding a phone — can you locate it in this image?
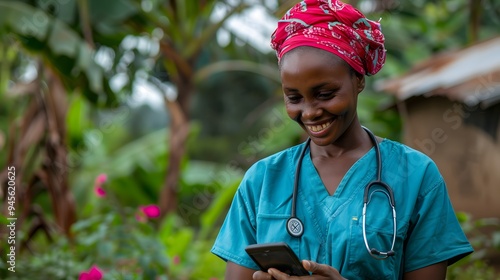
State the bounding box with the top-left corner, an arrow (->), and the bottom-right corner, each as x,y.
212,0 -> 472,280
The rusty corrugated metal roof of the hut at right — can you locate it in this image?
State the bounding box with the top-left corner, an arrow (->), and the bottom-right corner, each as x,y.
375,37 -> 500,107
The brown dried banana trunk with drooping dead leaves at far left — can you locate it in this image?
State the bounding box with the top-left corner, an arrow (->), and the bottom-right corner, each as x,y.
0,65 -> 76,243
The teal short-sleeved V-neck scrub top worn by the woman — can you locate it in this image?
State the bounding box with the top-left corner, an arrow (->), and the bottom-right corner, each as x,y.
212,139 -> 473,279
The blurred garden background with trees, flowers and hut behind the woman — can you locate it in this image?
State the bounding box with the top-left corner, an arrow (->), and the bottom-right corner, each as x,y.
0,0 -> 500,279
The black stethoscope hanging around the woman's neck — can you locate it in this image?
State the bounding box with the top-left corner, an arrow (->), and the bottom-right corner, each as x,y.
286,127 -> 396,259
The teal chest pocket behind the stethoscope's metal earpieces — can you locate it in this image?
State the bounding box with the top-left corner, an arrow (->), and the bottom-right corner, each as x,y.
347,197 -> 403,279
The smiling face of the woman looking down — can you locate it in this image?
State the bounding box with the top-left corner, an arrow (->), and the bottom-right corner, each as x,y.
281,47 -> 364,146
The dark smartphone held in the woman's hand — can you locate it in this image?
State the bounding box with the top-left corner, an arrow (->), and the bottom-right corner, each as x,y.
245,242 -> 310,276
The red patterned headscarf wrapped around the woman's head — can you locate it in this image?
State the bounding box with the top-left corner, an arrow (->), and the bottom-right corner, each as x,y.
271,0 -> 385,75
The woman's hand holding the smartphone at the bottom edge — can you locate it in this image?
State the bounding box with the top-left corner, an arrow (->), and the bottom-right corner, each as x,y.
253,260 -> 345,280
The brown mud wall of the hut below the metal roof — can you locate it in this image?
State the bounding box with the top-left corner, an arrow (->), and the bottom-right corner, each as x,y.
400,97 -> 500,218
